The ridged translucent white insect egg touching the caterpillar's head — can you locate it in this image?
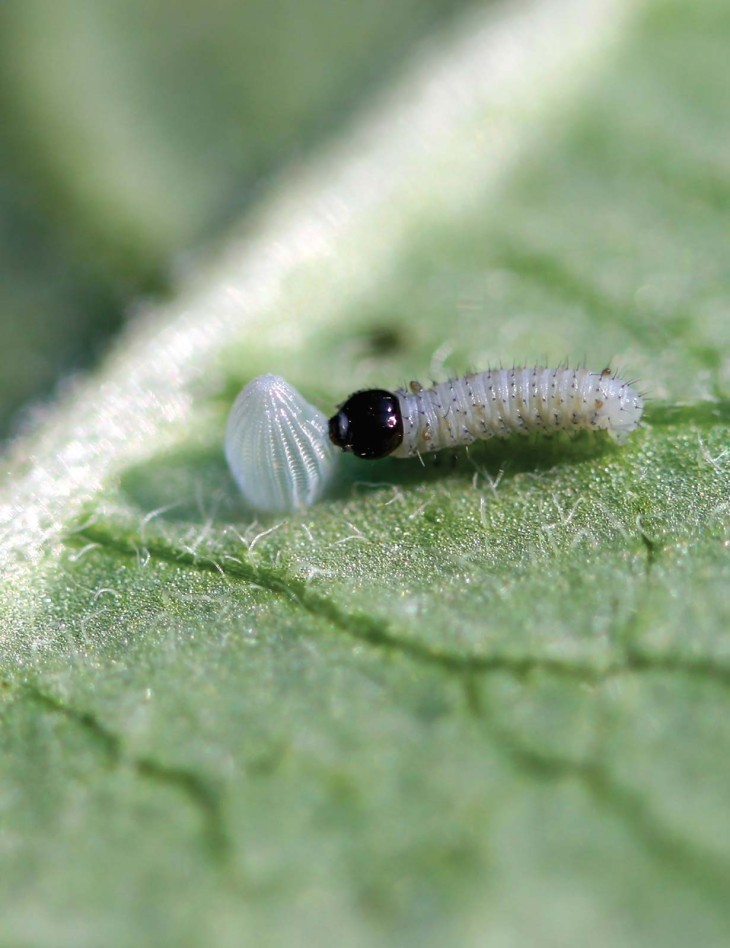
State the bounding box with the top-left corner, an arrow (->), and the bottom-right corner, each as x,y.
225,375 -> 336,513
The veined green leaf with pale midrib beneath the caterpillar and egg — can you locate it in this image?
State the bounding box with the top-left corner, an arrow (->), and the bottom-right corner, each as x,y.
0,0 -> 730,946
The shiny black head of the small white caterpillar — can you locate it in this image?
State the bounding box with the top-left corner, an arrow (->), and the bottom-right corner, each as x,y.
329,388 -> 403,461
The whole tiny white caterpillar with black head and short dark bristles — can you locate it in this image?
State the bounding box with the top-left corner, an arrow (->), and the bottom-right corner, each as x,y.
329,367 -> 644,460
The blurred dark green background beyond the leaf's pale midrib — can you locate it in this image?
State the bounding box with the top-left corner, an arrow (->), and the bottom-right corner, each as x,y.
0,0 -> 468,436
